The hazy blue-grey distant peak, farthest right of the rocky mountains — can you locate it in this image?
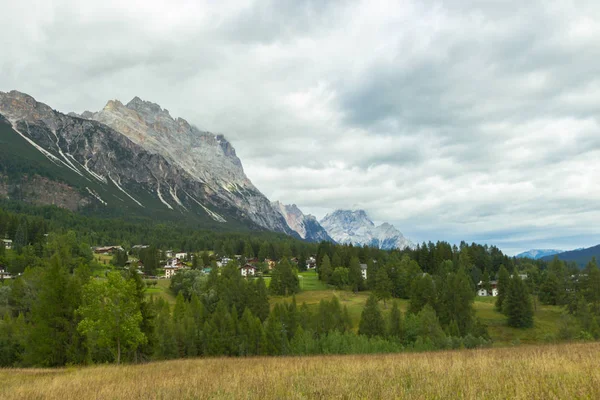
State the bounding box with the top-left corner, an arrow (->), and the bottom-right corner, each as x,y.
321,210 -> 414,250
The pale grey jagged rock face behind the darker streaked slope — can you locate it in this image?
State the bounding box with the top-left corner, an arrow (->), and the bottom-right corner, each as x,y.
87,97 -> 293,234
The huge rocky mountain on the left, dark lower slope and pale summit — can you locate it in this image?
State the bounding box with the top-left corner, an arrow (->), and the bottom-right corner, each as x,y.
0,91 -> 297,236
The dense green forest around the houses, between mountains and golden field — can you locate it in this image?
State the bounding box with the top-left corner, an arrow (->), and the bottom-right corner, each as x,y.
0,203 -> 600,367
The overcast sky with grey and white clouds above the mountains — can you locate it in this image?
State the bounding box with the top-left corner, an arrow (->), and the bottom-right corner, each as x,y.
0,0 -> 600,254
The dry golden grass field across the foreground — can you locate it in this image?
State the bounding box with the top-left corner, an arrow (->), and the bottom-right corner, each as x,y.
0,343 -> 600,400
